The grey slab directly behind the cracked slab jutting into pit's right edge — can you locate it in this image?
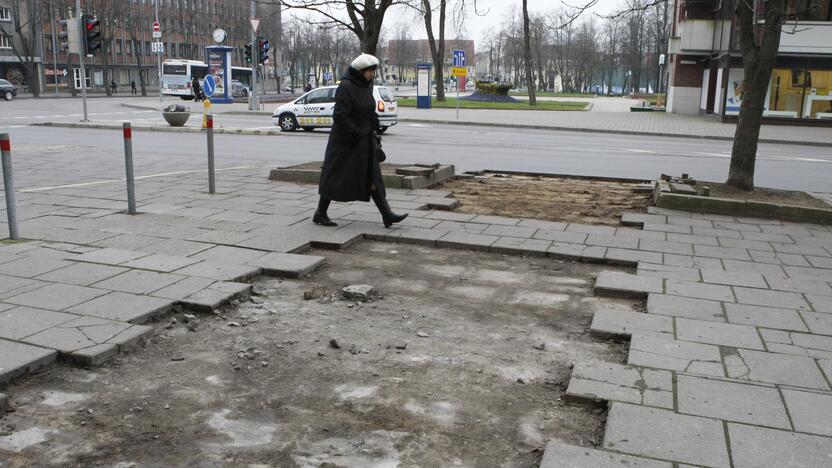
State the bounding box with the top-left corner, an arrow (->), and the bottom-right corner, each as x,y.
627,334 -> 725,377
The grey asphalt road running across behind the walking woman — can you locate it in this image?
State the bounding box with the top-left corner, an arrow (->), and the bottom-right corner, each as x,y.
0,98 -> 832,192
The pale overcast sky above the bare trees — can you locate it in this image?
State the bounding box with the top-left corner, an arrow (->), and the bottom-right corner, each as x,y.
384,0 -> 623,42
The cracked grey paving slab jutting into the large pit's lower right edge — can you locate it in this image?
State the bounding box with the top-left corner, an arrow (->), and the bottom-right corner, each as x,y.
565,361 -> 673,409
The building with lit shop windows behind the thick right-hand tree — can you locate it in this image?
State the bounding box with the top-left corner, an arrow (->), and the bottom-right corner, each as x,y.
667,0 -> 832,121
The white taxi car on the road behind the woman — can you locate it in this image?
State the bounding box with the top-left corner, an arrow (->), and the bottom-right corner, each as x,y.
272,85 -> 399,133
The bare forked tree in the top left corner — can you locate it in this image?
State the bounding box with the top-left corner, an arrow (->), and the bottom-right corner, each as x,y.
0,0 -> 46,98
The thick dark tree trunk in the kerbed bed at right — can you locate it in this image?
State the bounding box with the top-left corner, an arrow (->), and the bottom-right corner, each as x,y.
726,0 -> 785,190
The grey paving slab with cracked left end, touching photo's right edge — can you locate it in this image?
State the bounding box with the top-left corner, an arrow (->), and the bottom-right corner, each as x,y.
728,349 -> 829,390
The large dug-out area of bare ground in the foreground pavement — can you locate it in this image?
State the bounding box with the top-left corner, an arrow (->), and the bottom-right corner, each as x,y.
0,242 -> 640,468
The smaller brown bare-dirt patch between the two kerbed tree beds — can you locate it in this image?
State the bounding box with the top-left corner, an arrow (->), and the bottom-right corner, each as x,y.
438,175 -> 650,226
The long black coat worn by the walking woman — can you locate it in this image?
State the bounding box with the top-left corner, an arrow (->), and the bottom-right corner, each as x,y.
318,67 -> 384,202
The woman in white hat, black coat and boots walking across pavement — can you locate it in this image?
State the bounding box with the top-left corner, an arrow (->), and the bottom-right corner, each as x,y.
312,54 -> 407,228
